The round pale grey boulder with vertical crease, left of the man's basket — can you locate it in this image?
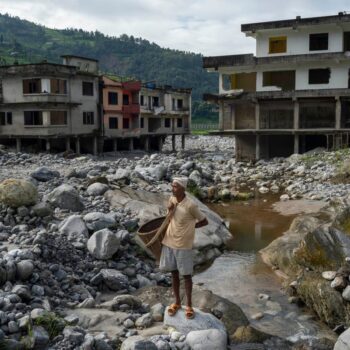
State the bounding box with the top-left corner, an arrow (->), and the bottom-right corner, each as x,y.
87,229 -> 120,260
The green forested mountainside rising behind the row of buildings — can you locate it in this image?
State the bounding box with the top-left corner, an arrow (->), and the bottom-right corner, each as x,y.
0,14 -> 218,117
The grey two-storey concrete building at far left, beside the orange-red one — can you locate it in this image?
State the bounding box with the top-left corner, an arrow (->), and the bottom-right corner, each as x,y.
0,56 -> 100,154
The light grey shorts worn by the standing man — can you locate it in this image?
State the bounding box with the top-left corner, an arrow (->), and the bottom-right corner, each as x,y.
159,245 -> 193,276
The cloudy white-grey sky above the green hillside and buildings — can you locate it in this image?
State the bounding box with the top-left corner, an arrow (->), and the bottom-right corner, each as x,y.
0,0 -> 350,56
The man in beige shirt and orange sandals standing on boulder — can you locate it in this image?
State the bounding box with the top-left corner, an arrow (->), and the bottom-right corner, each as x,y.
159,177 -> 208,319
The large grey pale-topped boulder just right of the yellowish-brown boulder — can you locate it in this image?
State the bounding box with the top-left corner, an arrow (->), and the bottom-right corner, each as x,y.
45,184 -> 85,212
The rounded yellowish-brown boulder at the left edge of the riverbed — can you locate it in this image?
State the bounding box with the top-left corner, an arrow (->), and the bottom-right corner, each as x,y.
0,179 -> 38,208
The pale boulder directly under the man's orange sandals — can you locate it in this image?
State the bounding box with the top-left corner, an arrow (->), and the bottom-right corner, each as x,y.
164,308 -> 226,335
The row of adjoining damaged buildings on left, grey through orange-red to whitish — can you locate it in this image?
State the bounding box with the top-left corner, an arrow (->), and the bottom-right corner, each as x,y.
0,55 -> 191,155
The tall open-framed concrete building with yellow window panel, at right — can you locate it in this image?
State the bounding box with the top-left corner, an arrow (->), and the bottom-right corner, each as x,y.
203,12 -> 350,160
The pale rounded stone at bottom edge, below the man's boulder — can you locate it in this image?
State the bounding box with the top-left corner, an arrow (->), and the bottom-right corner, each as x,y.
186,329 -> 227,350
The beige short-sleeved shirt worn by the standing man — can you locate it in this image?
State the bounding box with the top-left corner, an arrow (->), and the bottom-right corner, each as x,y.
162,196 -> 205,249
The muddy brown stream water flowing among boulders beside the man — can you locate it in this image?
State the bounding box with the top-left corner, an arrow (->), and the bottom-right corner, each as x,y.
194,196 -> 335,341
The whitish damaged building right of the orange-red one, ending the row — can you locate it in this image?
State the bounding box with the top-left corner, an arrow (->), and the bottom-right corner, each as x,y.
140,83 -> 191,150
